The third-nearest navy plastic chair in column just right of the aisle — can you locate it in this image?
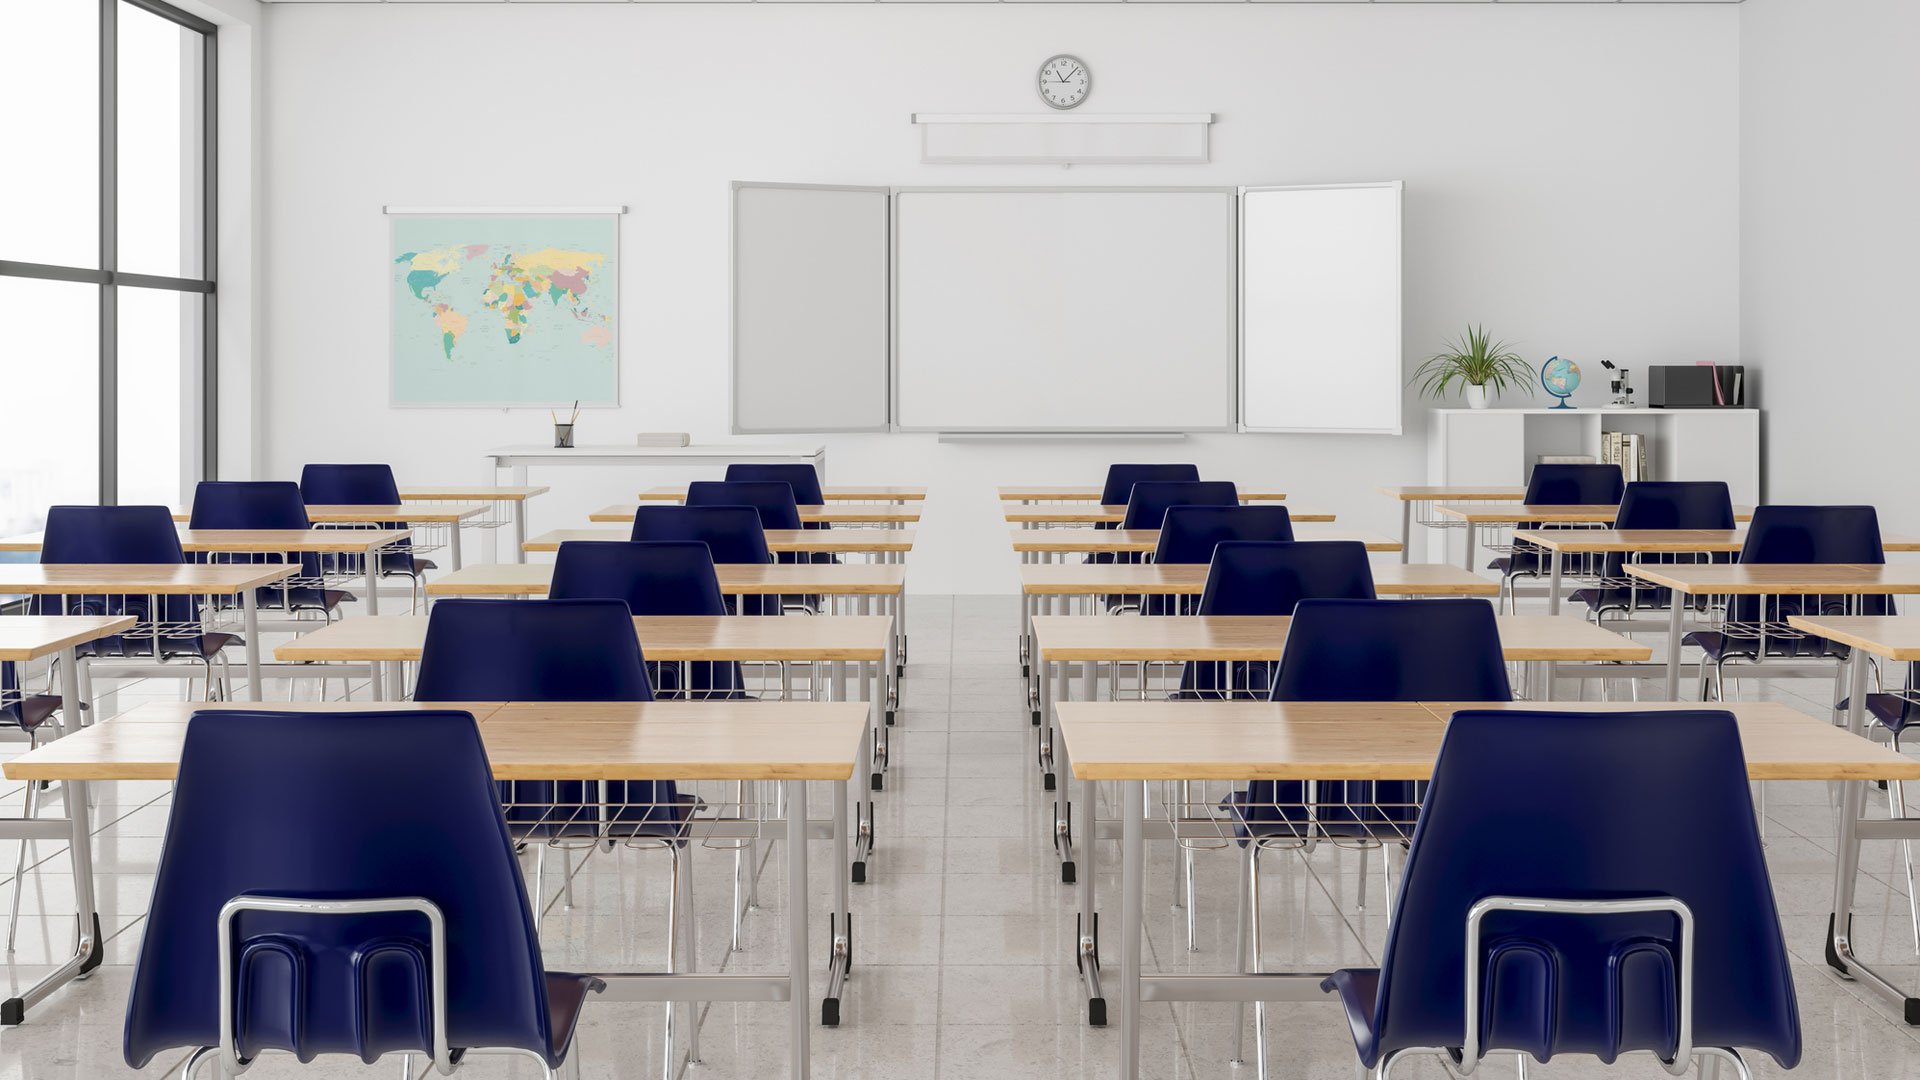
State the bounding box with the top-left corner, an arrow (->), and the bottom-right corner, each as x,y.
1167,538 -> 1373,701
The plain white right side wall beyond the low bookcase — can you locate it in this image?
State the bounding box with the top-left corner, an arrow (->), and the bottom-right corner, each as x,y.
1740,0 -> 1920,532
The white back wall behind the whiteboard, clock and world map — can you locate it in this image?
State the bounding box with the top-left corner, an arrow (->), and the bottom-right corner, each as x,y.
261,4 -> 1740,592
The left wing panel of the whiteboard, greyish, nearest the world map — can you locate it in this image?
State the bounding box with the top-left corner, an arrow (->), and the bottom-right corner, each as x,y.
733,183 -> 887,434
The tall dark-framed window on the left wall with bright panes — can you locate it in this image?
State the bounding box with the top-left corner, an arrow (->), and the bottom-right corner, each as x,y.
0,0 -> 215,534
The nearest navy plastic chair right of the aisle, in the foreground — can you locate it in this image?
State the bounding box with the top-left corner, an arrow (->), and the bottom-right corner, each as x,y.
1323,711 -> 1801,1078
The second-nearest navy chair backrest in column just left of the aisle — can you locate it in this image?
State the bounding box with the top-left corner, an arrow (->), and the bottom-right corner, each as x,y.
413,600 -> 653,701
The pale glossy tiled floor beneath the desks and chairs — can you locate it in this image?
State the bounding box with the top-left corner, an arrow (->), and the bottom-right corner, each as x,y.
0,596 -> 1920,1080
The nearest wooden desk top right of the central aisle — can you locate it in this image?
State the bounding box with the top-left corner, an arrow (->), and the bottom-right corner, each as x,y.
1059,701 -> 1920,780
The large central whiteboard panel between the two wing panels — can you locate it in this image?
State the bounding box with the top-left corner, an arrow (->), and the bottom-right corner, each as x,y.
893,188 -> 1235,432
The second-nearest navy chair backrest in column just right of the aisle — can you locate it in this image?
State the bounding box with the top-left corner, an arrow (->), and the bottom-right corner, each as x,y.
1273,600 -> 1513,701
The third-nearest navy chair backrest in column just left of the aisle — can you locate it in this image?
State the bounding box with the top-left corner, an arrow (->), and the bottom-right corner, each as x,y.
547,540 -> 726,615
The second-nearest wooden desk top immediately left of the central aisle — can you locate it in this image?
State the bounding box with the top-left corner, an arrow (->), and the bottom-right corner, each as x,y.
273,615 -> 891,663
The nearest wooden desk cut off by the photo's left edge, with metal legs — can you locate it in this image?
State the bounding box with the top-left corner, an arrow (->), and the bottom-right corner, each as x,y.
0,615 -> 136,1024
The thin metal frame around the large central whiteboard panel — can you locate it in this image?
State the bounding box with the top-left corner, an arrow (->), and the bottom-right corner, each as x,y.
887,184 -> 1244,434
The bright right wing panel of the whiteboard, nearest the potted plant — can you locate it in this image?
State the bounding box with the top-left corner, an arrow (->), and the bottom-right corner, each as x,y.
1240,181 -> 1404,434
